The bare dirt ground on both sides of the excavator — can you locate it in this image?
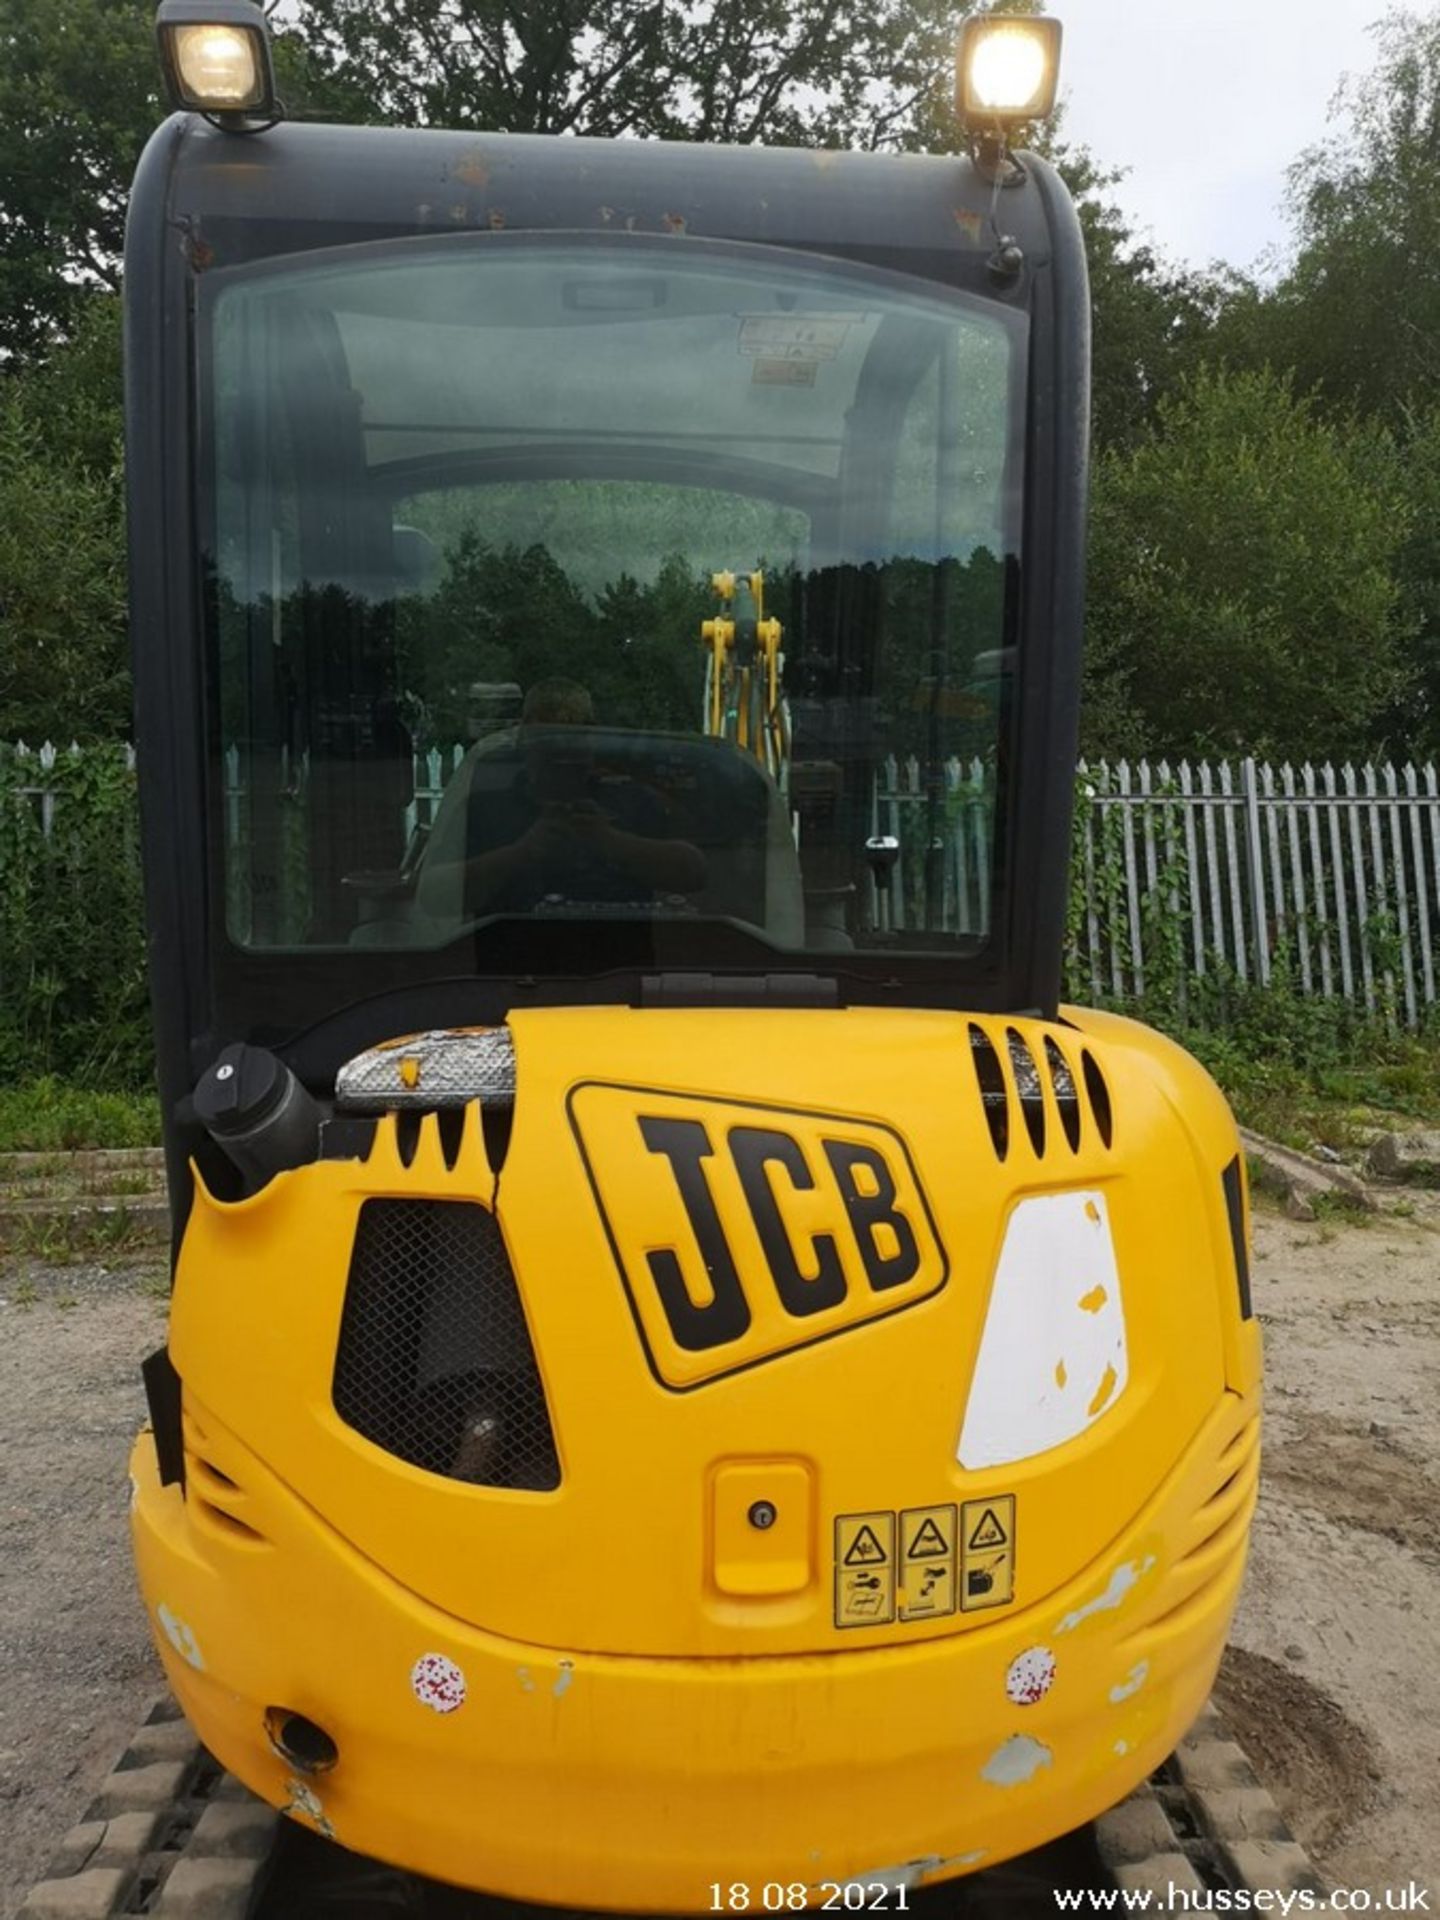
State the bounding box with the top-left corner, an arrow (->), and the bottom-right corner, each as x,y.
0,1206 -> 1440,1914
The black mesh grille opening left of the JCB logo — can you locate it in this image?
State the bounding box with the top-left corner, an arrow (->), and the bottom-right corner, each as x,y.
334,1200 -> 561,1492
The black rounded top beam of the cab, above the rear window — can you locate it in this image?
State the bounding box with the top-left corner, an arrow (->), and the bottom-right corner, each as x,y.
149,115 -> 1052,303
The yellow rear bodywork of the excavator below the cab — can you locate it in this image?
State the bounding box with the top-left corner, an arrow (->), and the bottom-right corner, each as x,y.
136,1008 -> 1260,1910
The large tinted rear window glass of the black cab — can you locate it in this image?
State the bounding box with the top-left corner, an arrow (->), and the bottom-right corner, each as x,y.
202,234 -> 1025,972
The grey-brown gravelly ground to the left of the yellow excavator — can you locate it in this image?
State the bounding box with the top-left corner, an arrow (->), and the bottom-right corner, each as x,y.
0,1256 -> 163,1914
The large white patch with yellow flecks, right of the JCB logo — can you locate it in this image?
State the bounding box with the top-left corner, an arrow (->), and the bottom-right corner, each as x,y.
956,1188 -> 1129,1469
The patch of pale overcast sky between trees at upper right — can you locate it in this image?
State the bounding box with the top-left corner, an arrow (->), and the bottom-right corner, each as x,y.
1046,0 -> 1388,278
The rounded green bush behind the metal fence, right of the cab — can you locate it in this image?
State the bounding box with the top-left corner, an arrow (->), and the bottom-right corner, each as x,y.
1085,371 -> 1407,758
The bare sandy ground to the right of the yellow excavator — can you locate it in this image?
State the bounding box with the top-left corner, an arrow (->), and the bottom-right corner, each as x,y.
1219,1208 -> 1440,1905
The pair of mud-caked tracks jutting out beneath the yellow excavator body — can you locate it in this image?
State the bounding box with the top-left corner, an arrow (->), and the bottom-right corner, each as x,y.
17,1697 -> 1327,1920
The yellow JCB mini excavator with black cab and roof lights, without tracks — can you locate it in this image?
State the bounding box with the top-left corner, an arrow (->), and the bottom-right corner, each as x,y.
125,0 -> 1260,1912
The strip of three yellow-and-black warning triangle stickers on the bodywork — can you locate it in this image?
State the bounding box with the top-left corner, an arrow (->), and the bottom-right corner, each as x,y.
835,1494 -> 1016,1626
